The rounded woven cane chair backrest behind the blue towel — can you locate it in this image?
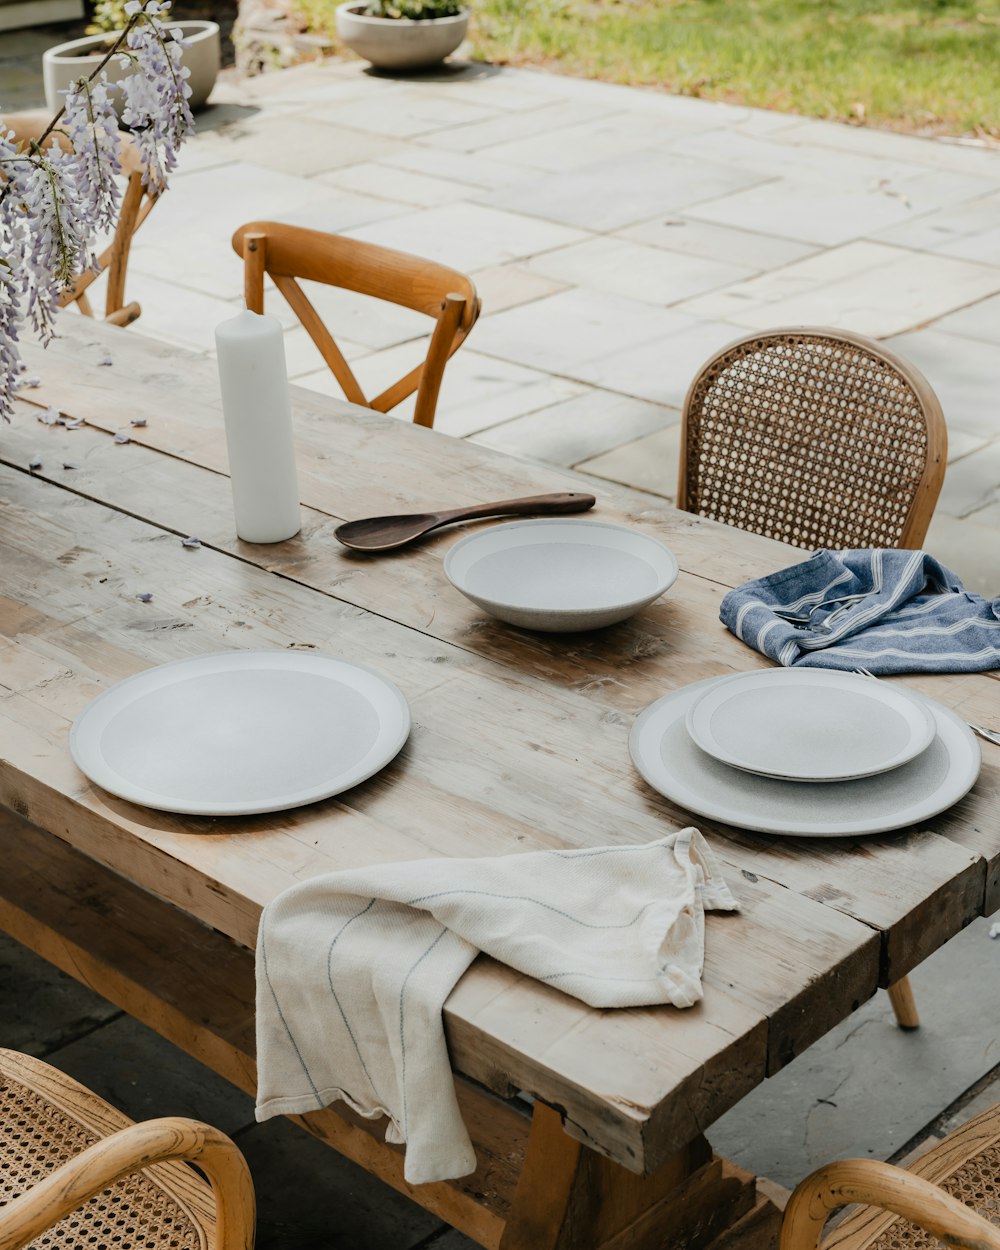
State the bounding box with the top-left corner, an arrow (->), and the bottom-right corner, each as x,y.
678,326 -> 948,548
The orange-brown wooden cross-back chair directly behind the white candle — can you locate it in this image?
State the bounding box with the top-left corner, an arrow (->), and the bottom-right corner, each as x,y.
233,221 -> 479,426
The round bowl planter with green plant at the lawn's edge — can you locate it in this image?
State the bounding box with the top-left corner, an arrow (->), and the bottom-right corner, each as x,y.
336,0 -> 469,70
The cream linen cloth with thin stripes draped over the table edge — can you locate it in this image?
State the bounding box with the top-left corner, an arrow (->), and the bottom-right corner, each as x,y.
256,829 -> 739,1184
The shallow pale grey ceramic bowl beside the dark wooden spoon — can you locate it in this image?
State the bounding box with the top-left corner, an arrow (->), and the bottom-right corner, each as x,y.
445,518 -> 678,631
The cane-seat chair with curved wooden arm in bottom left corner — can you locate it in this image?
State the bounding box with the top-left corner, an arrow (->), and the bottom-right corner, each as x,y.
0,1050 -> 254,1250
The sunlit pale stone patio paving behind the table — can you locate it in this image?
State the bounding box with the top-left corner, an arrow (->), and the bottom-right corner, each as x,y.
123,61 -> 1000,595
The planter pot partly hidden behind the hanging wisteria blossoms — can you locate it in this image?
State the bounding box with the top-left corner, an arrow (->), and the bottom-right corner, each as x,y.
41,0 -> 221,113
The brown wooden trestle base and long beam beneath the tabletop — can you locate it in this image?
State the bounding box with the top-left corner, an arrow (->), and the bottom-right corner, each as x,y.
0,813 -> 778,1250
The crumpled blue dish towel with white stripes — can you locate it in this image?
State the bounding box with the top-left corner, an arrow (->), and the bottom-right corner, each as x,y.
719,548 -> 1000,676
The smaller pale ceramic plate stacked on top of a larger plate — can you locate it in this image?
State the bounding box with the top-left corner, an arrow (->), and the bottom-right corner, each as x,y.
686,669 -> 936,781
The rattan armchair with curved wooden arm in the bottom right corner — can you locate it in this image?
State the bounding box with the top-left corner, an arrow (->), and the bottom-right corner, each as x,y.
780,1106 -> 1000,1250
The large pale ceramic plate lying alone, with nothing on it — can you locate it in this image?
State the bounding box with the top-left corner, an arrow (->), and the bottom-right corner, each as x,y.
70,651 -> 410,816
